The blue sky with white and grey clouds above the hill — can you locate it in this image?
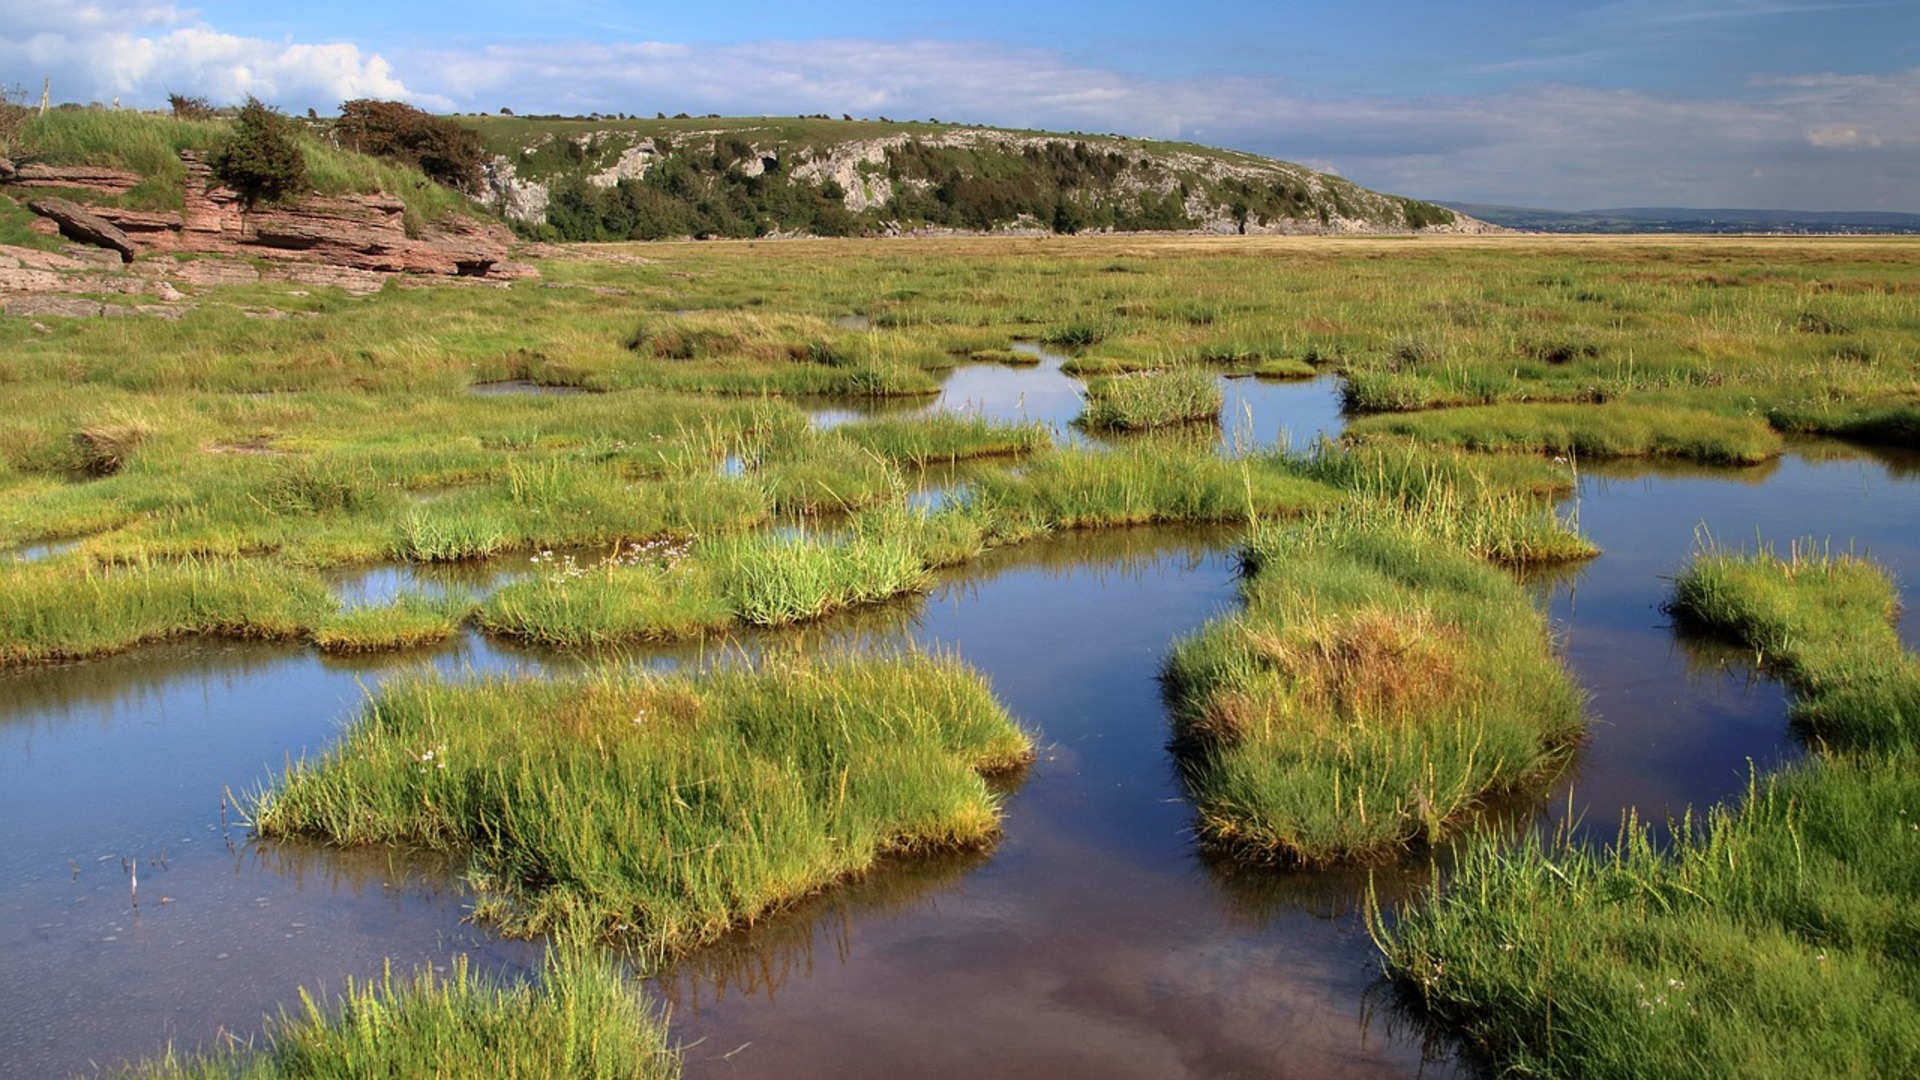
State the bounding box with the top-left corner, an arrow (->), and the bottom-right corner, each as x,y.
0,0 -> 1920,211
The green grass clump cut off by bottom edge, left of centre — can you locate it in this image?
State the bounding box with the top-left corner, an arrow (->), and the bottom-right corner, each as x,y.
113,945 -> 680,1080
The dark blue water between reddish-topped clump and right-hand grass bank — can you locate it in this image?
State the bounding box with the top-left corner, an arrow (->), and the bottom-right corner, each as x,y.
1532,444 -> 1920,840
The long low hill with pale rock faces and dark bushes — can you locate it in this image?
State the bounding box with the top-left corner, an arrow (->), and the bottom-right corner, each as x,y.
461,115 -> 1480,240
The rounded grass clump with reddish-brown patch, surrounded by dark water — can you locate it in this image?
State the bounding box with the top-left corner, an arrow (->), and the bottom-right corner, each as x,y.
1162,515 -> 1582,865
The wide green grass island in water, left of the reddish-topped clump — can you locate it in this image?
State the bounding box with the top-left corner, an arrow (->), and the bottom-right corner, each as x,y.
253,655 -> 1031,951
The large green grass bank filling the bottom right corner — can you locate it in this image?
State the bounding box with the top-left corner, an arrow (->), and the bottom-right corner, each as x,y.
1375,550 -> 1920,1078
